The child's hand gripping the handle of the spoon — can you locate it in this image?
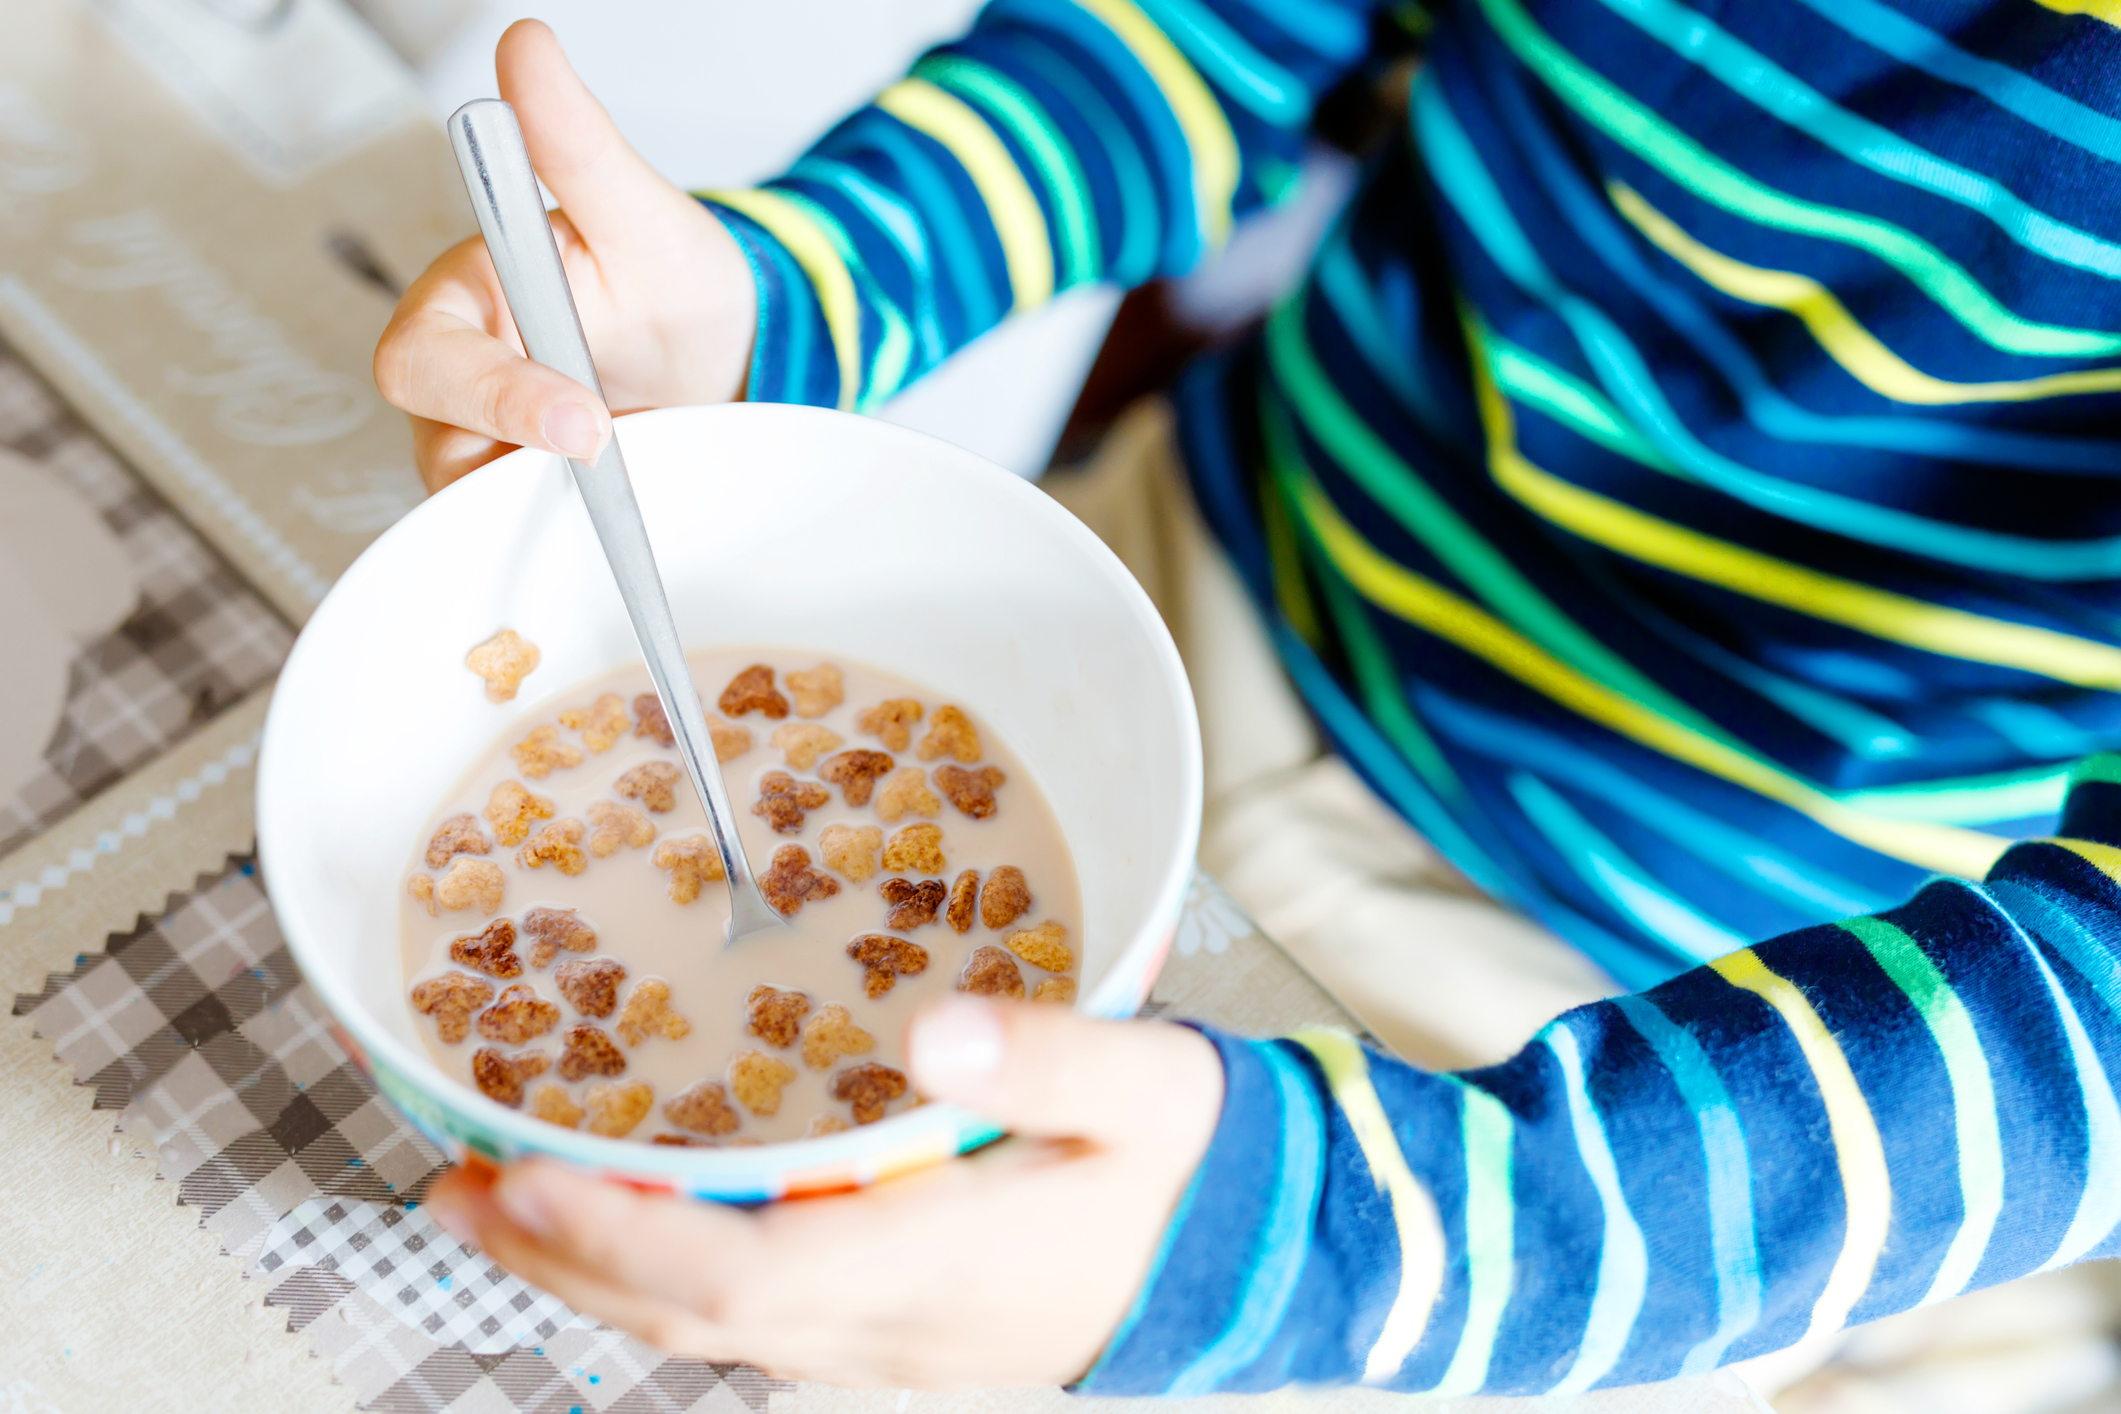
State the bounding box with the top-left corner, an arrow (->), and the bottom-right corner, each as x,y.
375,19 -> 757,492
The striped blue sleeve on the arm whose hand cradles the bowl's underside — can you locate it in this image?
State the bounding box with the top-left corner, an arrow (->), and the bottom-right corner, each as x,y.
1084,755 -> 2121,1395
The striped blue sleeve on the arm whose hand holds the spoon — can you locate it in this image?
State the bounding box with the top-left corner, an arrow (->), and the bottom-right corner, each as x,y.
704,0 -> 1374,411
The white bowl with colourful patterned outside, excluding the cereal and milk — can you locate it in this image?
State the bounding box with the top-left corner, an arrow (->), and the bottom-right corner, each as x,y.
259,403 -> 1200,1202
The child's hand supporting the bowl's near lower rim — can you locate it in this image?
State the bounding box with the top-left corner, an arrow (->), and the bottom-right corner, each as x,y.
428,998 -> 1222,1389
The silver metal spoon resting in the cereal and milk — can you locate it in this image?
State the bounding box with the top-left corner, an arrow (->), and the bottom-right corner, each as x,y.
450,98 -> 787,943
